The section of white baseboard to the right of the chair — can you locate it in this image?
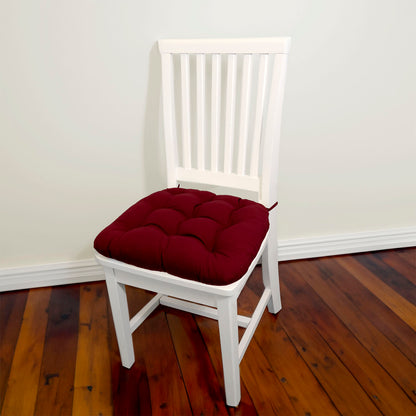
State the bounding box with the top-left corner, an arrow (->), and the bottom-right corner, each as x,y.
278,227 -> 416,261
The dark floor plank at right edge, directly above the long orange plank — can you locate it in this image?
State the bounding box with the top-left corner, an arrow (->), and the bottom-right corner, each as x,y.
354,253 -> 416,305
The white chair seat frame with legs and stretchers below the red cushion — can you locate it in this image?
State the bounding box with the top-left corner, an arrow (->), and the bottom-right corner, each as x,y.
95,219 -> 281,406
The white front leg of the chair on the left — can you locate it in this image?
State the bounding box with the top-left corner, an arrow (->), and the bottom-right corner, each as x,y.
105,269 -> 135,368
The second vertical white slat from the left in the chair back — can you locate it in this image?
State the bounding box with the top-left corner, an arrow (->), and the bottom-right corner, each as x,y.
196,54 -> 205,169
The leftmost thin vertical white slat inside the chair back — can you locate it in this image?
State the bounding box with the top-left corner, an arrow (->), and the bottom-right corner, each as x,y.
181,54 -> 192,169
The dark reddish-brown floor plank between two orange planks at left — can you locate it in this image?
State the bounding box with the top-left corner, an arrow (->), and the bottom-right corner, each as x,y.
35,285 -> 79,416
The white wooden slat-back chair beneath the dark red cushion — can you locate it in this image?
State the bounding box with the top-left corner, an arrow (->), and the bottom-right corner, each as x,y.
95,38 -> 290,406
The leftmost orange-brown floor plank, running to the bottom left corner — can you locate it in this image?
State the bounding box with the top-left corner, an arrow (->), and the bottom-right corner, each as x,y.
1,288 -> 51,416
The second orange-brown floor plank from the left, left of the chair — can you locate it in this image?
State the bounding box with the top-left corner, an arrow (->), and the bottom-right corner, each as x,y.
72,282 -> 113,416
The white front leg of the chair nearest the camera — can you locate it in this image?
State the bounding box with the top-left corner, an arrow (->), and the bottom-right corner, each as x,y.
217,298 -> 241,406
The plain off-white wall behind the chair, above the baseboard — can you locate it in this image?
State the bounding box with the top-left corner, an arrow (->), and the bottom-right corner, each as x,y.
0,0 -> 416,267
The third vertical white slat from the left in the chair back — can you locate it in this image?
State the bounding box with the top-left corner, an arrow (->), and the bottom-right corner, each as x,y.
211,54 -> 221,172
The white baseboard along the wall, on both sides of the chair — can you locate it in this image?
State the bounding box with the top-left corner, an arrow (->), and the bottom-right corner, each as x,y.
0,227 -> 416,292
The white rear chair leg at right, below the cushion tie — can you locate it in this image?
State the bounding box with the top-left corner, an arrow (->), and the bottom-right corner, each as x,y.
262,213 -> 282,313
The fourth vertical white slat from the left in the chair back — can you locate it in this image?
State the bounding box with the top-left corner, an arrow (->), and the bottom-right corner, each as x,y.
224,54 -> 237,173
